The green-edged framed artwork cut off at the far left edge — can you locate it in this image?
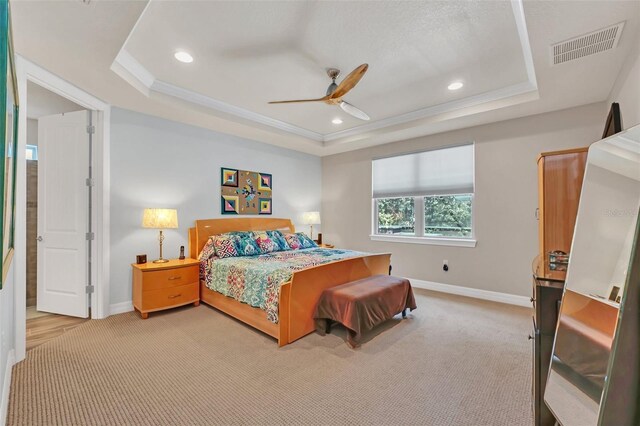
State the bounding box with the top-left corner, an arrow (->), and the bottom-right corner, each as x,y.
0,0 -> 19,289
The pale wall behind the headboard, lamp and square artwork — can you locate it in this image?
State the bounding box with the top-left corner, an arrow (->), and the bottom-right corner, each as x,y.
110,109 -> 321,304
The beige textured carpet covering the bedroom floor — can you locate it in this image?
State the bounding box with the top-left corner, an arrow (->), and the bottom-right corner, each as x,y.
8,290 -> 532,426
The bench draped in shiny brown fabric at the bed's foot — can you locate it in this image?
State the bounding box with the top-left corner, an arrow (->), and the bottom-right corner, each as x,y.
313,275 -> 416,347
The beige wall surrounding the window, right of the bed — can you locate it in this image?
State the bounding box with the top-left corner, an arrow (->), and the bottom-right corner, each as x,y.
322,103 -> 606,296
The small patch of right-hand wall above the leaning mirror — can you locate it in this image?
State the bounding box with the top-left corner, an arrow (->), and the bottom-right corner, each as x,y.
603,42 -> 640,129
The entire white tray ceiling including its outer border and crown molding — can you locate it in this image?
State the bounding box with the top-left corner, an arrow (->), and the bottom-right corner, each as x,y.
12,1 -> 640,155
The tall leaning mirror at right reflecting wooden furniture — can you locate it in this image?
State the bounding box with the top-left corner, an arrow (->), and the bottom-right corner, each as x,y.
544,126 -> 640,426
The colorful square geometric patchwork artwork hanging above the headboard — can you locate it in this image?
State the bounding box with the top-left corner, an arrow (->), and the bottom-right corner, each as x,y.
220,167 -> 273,215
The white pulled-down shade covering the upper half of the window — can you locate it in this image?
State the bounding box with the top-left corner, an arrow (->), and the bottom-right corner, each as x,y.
373,144 -> 474,198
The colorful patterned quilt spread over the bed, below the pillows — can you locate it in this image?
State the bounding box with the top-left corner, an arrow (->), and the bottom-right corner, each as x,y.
200,247 -> 368,324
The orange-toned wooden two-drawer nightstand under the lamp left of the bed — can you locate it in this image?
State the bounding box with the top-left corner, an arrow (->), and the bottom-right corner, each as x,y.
131,259 -> 200,319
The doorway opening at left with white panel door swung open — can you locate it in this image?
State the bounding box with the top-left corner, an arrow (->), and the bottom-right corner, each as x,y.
25,82 -> 91,349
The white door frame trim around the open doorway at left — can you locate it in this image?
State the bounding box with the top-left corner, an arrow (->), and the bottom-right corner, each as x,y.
14,55 -> 111,362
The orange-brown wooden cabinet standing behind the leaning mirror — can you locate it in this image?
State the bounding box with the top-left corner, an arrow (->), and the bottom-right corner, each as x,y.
538,147 -> 589,256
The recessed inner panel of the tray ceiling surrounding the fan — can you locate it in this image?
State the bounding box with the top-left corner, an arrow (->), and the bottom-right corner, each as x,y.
124,1 -> 527,134
